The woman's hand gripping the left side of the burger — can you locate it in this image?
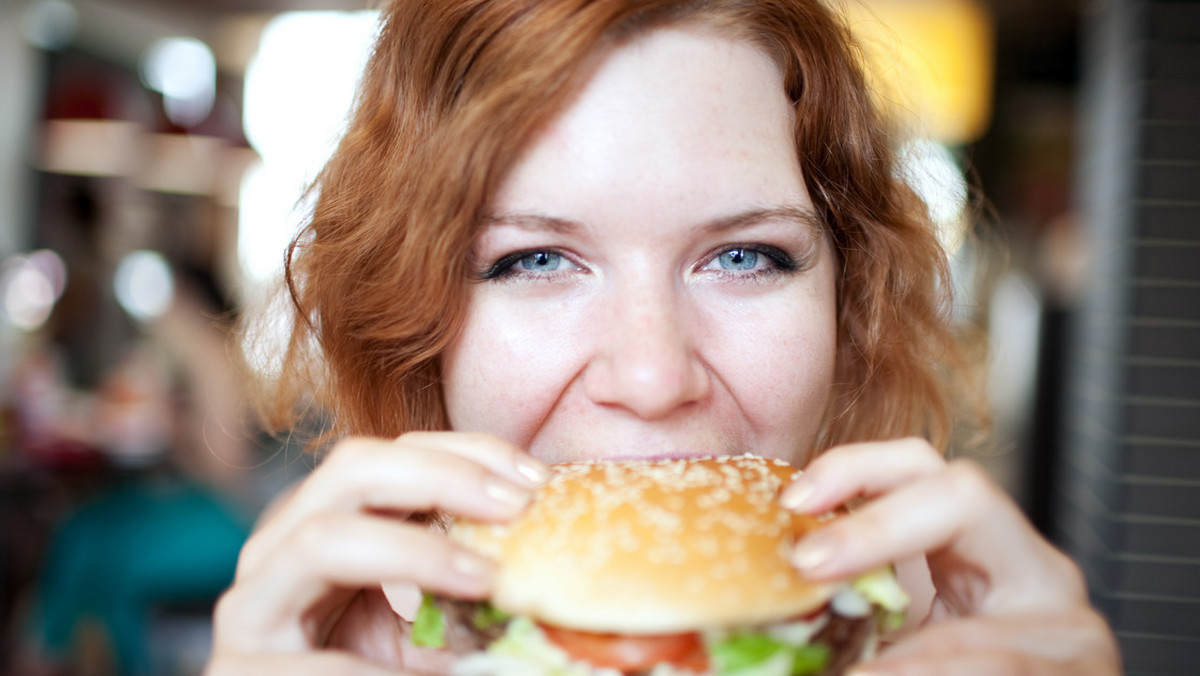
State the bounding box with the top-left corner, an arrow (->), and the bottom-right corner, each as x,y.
206,432 -> 550,676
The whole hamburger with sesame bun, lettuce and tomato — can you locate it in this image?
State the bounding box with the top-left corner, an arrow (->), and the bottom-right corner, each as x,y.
413,455 -> 907,676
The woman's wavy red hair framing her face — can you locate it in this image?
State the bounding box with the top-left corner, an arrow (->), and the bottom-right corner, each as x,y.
264,0 -> 979,448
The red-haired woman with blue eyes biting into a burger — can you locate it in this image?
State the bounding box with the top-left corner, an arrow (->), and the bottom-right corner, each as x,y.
210,0 -> 1117,674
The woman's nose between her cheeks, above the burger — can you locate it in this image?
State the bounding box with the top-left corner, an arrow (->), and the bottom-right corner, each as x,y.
583,278 -> 710,420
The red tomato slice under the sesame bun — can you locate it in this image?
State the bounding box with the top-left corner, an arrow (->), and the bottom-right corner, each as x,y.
541,624 -> 708,674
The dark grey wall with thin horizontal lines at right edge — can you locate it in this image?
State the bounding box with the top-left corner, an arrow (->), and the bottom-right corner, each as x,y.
1052,0 -> 1200,676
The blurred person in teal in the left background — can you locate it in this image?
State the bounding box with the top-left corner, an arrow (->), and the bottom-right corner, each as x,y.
14,268 -> 257,675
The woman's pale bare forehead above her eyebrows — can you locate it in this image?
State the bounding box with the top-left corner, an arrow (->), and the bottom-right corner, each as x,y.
497,25 -> 799,219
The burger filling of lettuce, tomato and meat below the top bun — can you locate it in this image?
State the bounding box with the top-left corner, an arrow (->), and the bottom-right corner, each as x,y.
413,570 -> 907,676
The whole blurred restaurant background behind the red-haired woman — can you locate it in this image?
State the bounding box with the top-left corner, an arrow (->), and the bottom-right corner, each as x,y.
0,0 -> 1200,675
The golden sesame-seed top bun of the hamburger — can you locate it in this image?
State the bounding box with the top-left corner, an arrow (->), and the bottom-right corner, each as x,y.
451,455 -> 833,634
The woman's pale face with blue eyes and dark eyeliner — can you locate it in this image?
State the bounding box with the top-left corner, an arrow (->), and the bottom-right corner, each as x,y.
443,28 -> 836,463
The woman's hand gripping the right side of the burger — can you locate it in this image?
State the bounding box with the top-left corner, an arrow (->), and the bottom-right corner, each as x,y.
782,439 -> 1121,676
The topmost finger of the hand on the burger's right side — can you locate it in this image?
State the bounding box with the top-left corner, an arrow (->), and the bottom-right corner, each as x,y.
780,437 -> 946,514
